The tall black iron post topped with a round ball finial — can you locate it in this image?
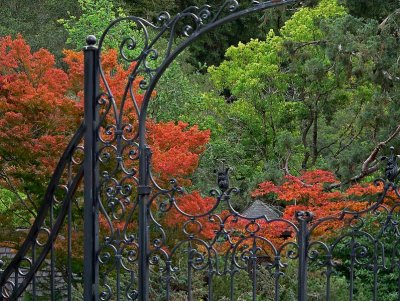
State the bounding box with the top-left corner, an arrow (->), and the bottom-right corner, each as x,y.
83,36 -> 99,301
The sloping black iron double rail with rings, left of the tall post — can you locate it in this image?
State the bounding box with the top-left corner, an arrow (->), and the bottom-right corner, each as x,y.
0,124 -> 84,300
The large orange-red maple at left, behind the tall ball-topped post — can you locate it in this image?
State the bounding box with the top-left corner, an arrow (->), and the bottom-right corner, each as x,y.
0,36 -> 210,219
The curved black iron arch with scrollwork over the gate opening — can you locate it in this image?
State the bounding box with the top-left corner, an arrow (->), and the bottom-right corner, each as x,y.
94,0 -> 300,155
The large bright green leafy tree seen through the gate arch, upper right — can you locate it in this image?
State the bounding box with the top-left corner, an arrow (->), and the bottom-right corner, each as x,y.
196,0 -> 399,192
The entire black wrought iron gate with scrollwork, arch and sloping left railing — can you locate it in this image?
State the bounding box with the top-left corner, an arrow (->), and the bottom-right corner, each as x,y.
0,0 -> 400,301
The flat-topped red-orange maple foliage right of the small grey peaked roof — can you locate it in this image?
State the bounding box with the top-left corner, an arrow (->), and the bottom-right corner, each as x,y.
252,170 -> 382,237
